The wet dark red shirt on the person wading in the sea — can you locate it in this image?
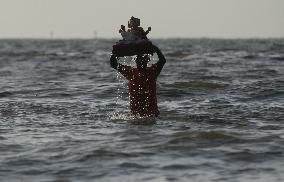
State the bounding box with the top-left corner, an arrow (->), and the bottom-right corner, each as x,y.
120,64 -> 159,116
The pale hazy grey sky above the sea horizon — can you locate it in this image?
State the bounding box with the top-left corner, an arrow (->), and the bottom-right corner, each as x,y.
0,0 -> 284,38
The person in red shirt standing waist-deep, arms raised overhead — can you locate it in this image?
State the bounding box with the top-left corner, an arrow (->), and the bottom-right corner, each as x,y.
110,45 -> 166,117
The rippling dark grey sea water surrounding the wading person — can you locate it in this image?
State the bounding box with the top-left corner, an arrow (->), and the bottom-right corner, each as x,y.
0,39 -> 284,182
